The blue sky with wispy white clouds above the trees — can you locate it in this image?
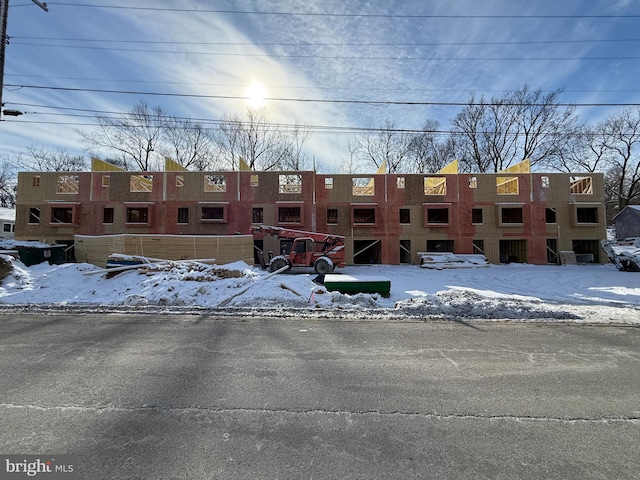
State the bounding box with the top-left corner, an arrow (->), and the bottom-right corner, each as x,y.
0,0 -> 640,169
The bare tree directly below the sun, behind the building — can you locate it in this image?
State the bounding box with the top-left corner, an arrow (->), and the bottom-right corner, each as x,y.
216,107 -> 308,170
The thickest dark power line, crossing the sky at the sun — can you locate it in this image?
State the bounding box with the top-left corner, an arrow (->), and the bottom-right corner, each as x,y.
6,84 -> 640,107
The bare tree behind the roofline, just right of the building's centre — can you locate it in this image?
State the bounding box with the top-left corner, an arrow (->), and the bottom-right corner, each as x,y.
351,120 -> 412,173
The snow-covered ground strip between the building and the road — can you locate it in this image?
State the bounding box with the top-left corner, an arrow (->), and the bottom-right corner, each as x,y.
0,256 -> 640,324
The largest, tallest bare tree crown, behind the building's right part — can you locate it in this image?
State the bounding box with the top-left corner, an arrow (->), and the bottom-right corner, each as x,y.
453,85 -> 576,172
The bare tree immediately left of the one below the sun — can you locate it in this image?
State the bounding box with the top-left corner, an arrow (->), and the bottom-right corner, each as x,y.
158,117 -> 219,171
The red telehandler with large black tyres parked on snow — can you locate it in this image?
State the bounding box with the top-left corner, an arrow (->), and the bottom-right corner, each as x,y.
251,225 -> 345,275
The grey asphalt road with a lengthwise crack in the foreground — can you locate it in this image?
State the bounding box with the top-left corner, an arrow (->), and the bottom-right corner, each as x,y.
0,314 -> 640,480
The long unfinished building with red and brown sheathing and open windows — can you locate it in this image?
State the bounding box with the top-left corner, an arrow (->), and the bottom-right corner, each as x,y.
15,161 -> 607,264
